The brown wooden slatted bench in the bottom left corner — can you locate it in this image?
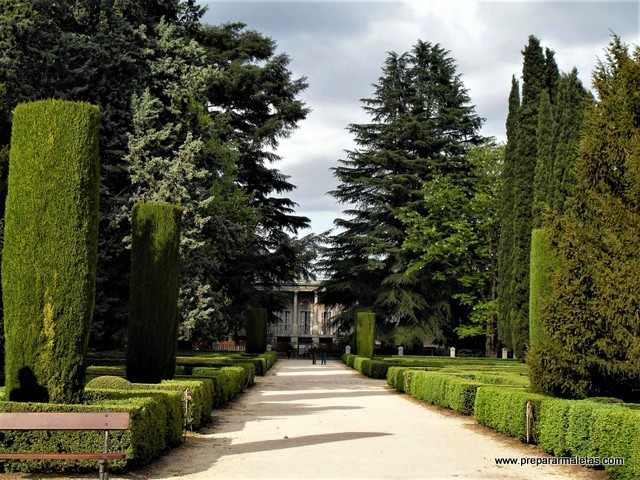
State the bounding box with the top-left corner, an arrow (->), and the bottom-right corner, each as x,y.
0,412 -> 129,480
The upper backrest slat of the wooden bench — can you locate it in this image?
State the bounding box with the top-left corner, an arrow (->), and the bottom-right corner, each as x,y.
0,412 -> 129,430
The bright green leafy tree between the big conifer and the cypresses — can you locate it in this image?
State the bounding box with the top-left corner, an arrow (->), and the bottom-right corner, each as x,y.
400,143 -> 503,353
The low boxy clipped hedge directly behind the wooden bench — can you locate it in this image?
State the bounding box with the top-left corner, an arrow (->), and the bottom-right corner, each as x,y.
0,397 -> 167,472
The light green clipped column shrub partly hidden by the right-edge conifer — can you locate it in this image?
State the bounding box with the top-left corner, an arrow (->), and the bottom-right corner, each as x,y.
529,228 -> 556,347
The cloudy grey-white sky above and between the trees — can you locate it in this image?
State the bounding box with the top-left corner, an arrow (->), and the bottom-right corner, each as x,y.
203,0 -> 640,234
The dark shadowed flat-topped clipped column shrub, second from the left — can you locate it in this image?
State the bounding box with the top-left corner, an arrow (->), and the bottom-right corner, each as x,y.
127,202 -> 182,383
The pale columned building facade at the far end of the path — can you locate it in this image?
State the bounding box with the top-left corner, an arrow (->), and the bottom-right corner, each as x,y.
267,282 -> 338,352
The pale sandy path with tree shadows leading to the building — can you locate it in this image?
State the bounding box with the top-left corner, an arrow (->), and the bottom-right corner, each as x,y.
129,360 -> 606,480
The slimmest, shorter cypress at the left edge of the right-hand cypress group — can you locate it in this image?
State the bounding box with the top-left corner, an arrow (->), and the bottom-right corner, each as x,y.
498,76 -> 520,348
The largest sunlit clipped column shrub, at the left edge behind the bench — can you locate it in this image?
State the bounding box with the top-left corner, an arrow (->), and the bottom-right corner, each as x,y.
2,100 -> 100,402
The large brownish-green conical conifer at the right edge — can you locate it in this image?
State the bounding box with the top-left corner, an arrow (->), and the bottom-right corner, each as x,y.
528,37 -> 640,400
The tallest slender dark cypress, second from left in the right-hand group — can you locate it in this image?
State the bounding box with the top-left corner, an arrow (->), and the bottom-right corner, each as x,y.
509,36 -> 547,358
